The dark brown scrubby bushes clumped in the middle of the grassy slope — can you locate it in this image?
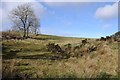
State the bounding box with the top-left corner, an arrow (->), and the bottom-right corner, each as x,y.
46,39 -> 97,58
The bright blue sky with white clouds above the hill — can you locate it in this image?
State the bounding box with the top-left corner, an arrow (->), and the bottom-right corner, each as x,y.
0,0 -> 118,38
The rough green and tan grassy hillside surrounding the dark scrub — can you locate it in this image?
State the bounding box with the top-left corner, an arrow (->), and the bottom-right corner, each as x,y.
2,32 -> 118,78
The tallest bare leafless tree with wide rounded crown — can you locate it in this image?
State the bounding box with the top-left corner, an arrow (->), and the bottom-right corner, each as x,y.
10,4 -> 39,37
